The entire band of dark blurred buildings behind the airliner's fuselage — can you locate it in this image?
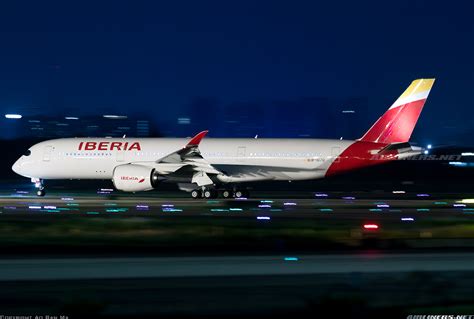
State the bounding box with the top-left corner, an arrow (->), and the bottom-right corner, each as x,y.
0,97 -> 372,140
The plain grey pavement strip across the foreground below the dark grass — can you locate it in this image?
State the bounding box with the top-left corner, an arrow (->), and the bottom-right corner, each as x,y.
0,253 -> 474,281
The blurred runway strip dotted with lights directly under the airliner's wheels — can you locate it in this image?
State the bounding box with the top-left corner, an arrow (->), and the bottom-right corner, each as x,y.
0,190 -> 474,219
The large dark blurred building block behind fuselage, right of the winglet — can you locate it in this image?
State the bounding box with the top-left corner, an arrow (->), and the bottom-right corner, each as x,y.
172,97 -> 372,139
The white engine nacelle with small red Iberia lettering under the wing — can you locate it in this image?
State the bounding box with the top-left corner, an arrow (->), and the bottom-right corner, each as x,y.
112,164 -> 156,192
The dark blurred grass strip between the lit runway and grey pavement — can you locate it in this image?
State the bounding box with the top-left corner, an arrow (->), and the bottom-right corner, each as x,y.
0,216 -> 474,252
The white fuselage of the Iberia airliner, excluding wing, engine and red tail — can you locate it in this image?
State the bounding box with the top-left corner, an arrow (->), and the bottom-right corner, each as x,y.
13,138 -> 354,182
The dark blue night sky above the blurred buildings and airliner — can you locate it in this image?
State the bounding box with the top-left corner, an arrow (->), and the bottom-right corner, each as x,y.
0,0 -> 474,143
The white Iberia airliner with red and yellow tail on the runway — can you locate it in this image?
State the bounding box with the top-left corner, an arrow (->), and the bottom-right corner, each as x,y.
12,79 -> 435,198
